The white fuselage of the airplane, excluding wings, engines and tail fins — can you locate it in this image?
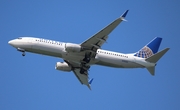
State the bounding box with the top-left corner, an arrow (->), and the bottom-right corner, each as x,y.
9,37 -> 155,68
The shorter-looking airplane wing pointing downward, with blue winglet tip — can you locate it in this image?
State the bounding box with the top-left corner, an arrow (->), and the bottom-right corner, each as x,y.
65,60 -> 93,90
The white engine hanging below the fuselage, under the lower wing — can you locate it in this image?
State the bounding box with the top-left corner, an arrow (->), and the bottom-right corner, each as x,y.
55,62 -> 72,72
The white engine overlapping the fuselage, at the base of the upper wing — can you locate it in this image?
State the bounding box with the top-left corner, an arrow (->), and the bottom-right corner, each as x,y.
66,43 -> 82,52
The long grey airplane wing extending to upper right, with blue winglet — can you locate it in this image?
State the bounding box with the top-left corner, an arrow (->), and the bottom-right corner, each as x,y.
81,10 -> 129,51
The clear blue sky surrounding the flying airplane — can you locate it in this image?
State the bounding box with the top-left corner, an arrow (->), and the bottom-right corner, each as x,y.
0,0 -> 180,110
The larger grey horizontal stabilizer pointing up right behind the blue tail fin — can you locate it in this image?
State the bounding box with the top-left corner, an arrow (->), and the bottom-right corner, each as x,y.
146,48 -> 169,63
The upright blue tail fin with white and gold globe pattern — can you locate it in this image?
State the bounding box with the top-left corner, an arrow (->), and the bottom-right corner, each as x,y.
134,37 -> 162,58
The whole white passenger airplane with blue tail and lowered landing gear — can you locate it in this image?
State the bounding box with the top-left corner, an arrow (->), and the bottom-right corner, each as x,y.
8,10 -> 170,90
